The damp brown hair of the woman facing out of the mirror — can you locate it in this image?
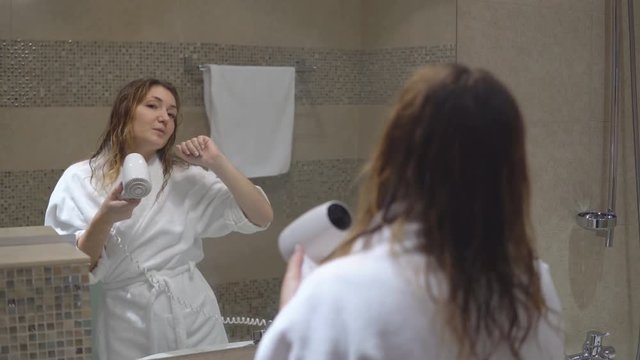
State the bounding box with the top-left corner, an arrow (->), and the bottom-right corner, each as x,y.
89,79 -> 180,191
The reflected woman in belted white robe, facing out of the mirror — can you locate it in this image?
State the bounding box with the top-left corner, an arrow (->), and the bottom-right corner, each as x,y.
45,79 -> 273,360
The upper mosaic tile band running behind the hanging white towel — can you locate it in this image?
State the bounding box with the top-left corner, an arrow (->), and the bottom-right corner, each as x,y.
0,39 -> 456,107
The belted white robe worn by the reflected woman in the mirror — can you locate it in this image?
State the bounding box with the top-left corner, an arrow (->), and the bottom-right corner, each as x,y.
45,157 -> 266,360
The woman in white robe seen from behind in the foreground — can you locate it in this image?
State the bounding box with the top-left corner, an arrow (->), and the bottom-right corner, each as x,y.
256,65 -> 564,360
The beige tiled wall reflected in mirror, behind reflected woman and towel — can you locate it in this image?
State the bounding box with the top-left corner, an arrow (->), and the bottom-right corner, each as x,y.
0,0 -> 456,358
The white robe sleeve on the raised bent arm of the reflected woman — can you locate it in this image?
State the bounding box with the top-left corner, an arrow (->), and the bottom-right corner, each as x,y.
185,167 -> 269,238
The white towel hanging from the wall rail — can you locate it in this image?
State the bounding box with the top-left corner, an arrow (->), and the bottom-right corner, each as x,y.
203,65 -> 295,177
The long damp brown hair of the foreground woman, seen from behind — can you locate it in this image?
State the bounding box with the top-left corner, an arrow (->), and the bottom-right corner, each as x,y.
336,65 -> 546,359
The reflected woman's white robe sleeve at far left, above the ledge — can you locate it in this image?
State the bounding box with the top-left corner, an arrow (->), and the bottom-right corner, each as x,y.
44,163 -> 109,283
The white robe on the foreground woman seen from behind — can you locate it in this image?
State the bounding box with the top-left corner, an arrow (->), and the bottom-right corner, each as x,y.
255,224 -> 564,360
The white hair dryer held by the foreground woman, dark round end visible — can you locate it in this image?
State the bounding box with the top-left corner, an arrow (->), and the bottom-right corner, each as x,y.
278,200 -> 351,277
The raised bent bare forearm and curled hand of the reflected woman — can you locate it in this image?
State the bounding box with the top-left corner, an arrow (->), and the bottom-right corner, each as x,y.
176,135 -> 273,227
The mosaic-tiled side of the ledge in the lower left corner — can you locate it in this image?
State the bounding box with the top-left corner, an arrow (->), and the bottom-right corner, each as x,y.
0,264 -> 92,360
